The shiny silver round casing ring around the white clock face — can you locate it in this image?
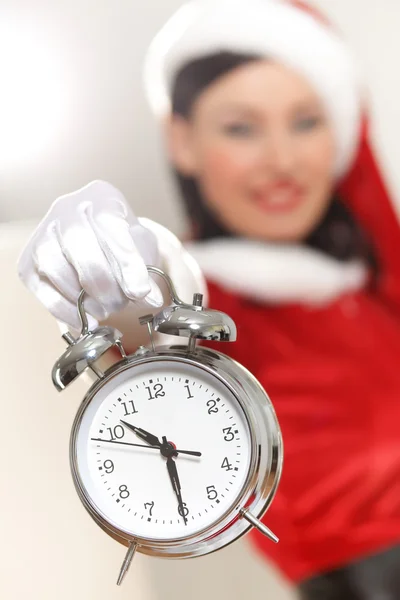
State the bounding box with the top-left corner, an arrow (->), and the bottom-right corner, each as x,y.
70,345 -> 283,559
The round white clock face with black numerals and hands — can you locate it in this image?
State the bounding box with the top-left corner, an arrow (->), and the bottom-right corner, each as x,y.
75,359 -> 251,541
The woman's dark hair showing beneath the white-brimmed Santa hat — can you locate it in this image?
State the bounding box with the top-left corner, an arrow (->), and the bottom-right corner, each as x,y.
172,52 -> 376,270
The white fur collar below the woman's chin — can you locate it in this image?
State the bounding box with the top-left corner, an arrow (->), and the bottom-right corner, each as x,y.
186,238 -> 368,306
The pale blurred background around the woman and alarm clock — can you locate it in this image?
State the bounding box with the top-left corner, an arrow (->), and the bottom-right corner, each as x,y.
0,0 -> 400,600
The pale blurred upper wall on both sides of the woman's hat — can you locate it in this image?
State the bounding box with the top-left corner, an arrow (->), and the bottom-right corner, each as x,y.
0,0 -> 400,233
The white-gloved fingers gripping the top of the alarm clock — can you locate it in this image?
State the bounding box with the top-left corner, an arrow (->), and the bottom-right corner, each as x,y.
18,181 -> 163,331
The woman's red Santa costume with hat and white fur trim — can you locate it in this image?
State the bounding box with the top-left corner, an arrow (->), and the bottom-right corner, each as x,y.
146,0 -> 400,582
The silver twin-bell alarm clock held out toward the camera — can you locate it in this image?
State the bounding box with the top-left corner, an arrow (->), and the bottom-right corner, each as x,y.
52,266 -> 283,585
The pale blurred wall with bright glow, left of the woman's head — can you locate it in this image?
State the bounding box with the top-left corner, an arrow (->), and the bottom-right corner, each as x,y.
0,0 -> 180,232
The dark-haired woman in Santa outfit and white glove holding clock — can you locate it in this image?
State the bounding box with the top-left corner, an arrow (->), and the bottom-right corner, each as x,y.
19,0 -> 400,600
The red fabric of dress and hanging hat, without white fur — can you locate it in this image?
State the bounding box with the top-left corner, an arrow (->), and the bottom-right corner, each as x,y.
203,129 -> 400,582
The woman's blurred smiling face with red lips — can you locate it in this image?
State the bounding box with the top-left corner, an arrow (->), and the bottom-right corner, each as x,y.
169,60 -> 335,241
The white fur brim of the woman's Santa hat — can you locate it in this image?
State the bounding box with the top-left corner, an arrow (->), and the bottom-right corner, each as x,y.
144,0 -> 361,177
